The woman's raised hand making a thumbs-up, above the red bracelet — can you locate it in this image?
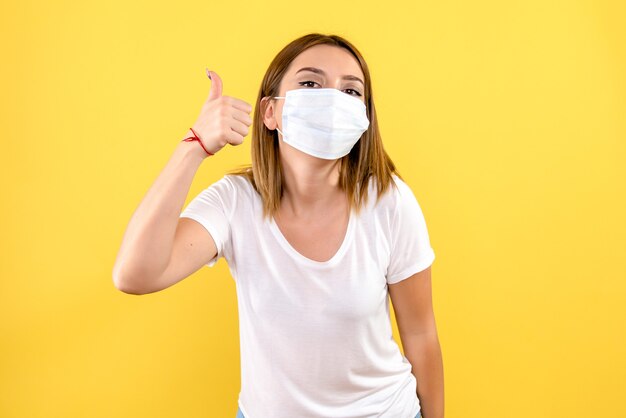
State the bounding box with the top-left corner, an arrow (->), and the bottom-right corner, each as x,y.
192,70 -> 252,155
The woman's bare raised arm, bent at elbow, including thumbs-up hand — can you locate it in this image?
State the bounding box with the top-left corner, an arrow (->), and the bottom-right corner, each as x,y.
113,70 -> 252,294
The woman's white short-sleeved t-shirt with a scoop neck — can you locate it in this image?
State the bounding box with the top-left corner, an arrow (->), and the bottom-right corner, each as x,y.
180,174 -> 435,418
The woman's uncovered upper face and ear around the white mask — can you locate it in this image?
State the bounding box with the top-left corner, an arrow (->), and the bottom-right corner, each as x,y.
264,45 -> 365,142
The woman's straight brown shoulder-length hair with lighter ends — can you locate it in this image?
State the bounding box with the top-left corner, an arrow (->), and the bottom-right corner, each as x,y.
228,33 -> 402,218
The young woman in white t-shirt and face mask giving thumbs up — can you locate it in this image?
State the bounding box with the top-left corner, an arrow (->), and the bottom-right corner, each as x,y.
113,33 -> 444,418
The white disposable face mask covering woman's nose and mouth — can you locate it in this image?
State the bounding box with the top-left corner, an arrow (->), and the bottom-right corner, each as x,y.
274,88 -> 370,160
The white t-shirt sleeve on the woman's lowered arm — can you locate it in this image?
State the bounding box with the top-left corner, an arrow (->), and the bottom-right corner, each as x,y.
386,178 -> 435,284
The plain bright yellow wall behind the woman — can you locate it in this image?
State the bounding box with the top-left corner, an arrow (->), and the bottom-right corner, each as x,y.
0,0 -> 626,418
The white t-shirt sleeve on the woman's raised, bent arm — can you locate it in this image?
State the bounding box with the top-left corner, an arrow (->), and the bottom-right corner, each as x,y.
180,176 -> 237,267
